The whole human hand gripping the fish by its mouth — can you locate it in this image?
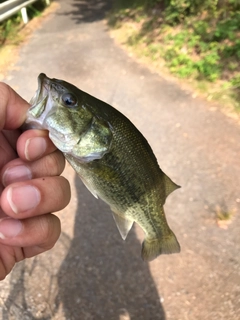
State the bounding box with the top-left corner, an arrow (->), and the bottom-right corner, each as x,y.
0,82 -> 70,280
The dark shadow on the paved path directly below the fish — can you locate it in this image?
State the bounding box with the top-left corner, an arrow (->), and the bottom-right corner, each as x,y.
55,177 -> 165,320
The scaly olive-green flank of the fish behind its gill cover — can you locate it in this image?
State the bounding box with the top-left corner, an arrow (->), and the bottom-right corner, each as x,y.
66,108 -> 165,234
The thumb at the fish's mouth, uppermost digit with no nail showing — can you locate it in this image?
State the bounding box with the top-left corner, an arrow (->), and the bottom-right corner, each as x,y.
0,82 -> 30,130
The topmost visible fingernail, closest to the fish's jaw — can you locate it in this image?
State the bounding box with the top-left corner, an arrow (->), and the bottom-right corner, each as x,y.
24,137 -> 47,160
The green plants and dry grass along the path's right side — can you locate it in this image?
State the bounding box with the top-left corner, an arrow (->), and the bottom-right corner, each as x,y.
108,0 -> 240,112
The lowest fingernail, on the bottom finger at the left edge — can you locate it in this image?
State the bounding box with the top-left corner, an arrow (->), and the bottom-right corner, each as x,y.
0,218 -> 22,239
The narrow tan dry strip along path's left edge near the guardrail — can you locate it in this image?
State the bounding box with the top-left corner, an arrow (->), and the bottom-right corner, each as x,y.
0,2 -> 60,81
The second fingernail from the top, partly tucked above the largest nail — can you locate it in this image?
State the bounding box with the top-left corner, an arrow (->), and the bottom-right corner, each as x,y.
2,165 -> 32,187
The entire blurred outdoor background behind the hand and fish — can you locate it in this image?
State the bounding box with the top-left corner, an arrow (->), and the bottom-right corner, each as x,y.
0,0 -> 240,320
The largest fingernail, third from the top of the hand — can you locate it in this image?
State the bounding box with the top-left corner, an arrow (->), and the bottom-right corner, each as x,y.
7,185 -> 41,213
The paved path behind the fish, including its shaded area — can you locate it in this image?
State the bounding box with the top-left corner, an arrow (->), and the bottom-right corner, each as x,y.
0,0 -> 240,320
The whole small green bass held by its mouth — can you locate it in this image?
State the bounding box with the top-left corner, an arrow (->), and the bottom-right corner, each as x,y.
26,73 -> 180,261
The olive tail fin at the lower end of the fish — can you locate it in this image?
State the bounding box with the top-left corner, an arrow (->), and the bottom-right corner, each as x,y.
142,230 -> 181,261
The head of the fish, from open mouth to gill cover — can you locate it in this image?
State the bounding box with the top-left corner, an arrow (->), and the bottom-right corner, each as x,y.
26,73 -> 112,161
